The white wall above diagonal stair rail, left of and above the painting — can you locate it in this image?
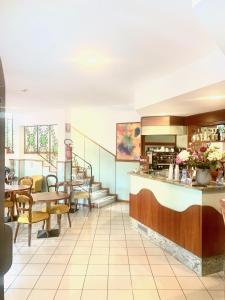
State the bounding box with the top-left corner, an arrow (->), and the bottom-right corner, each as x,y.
70,106 -> 140,154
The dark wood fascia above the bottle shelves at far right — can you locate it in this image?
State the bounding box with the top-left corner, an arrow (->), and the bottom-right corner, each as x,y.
185,109 -> 225,126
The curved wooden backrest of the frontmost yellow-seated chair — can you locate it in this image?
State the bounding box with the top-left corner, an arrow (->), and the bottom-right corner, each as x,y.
15,191 -> 34,222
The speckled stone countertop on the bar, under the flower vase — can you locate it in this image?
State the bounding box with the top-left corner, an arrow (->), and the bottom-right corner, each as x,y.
129,172 -> 225,193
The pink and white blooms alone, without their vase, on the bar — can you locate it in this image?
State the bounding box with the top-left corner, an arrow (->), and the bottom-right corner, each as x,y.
176,145 -> 225,169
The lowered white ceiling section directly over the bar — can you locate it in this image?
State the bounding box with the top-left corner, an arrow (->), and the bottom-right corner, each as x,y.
139,81 -> 225,116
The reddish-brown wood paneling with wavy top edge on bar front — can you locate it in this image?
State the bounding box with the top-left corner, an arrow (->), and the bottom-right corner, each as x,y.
130,189 -> 224,257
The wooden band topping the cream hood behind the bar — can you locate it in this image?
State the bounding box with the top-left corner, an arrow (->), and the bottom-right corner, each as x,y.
141,116 -> 184,126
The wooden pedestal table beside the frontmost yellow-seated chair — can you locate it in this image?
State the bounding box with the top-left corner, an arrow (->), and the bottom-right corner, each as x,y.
32,192 -> 69,238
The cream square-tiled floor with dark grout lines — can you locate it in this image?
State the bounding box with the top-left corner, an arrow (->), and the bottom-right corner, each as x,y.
5,203 -> 225,300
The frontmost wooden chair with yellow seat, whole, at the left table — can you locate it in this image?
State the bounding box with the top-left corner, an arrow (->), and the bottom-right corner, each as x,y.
14,191 -> 49,246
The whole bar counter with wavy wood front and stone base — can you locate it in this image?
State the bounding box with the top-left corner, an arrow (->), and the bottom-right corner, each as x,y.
130,173 -> 225,275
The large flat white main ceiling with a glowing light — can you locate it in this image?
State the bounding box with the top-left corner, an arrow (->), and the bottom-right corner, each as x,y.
0,0 -> 218,107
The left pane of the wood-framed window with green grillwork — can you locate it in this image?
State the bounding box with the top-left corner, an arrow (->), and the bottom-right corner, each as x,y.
24,126 -> 37,153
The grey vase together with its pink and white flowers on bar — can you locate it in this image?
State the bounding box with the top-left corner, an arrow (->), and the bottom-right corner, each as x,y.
176,145 -> 225,185
